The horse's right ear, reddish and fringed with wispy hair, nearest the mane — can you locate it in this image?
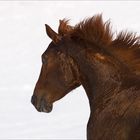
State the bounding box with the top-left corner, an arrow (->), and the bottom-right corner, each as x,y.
58,19 -> 73,36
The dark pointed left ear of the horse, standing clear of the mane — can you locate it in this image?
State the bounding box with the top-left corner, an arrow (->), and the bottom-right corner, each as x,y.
45,24 -> 61,43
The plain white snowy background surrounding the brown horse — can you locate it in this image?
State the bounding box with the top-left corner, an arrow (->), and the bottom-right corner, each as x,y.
0,1 -> 140,139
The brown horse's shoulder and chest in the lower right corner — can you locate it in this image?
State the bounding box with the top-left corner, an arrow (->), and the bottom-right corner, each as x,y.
87,88 -> 140,140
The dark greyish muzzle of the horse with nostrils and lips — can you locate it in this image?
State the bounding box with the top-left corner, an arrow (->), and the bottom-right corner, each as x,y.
31,95 -> 53,113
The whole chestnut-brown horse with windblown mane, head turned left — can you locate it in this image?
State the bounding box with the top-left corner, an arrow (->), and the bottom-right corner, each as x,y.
31,14 -> 140,140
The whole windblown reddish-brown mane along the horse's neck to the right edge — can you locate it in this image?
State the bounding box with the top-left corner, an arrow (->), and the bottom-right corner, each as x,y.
62,15 -> 140,74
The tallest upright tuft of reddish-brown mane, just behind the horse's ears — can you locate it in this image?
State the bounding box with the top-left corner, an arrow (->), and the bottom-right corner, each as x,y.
72,15 -> 113,44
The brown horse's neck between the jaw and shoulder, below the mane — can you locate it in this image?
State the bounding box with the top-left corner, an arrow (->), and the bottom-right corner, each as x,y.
68,41 -> 137,110
